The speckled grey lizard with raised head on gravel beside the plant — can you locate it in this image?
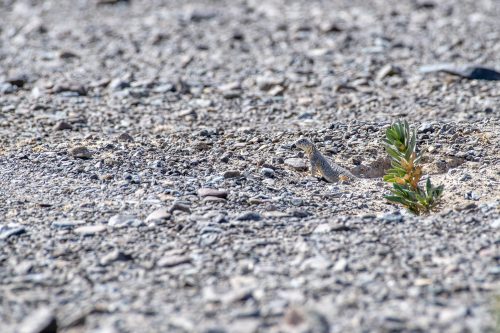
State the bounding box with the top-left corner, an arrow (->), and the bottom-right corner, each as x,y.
294,138 -> 357,183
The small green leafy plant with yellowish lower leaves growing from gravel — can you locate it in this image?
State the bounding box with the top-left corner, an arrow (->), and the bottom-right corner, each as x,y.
384,121 -> 444,215
